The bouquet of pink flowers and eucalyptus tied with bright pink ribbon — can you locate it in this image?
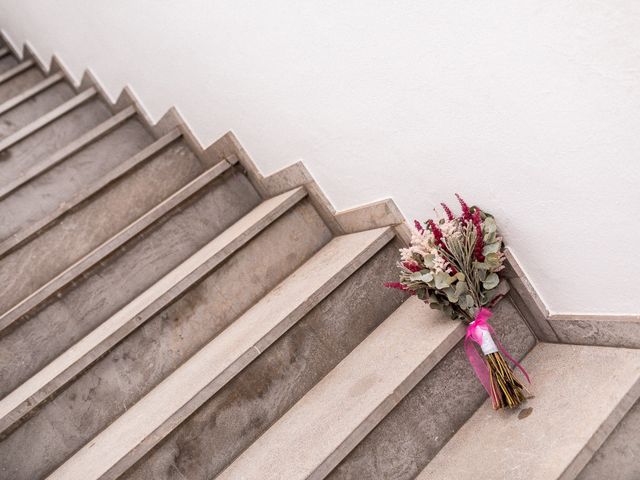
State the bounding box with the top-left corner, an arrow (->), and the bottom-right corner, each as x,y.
385,194 -> 529,410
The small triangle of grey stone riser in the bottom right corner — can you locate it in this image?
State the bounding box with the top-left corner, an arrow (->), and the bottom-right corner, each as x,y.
577,400 -> 640,480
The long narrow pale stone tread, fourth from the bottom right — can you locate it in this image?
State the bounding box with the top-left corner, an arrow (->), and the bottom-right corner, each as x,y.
0,187 -> 307,438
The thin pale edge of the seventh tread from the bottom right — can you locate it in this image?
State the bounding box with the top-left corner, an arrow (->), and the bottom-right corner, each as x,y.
0,106 -> 136,201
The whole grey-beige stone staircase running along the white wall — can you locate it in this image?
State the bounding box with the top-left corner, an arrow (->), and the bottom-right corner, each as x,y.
0,34 -> 640,480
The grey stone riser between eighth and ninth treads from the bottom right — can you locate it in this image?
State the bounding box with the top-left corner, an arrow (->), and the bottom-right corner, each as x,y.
0,83 -> 75,138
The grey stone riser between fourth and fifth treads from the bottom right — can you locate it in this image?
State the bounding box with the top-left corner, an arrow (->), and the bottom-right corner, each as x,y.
0,167 -> 259,397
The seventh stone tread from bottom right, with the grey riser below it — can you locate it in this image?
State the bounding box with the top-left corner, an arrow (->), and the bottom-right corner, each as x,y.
0,109 -> 153,241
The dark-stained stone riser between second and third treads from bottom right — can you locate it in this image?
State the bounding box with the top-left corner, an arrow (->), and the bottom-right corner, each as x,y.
124,242 -> 402,479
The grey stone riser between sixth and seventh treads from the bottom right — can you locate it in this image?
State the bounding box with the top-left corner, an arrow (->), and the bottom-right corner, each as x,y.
0,120 -> 153,239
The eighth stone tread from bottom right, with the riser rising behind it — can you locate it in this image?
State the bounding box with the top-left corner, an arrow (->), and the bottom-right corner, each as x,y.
0,83 -> 91,145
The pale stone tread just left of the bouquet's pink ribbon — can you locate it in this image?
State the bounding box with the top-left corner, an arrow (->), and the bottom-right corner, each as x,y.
216,297 -> 464,480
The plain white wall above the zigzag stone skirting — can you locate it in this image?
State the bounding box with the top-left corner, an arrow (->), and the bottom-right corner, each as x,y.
0,0 -> 640,313
